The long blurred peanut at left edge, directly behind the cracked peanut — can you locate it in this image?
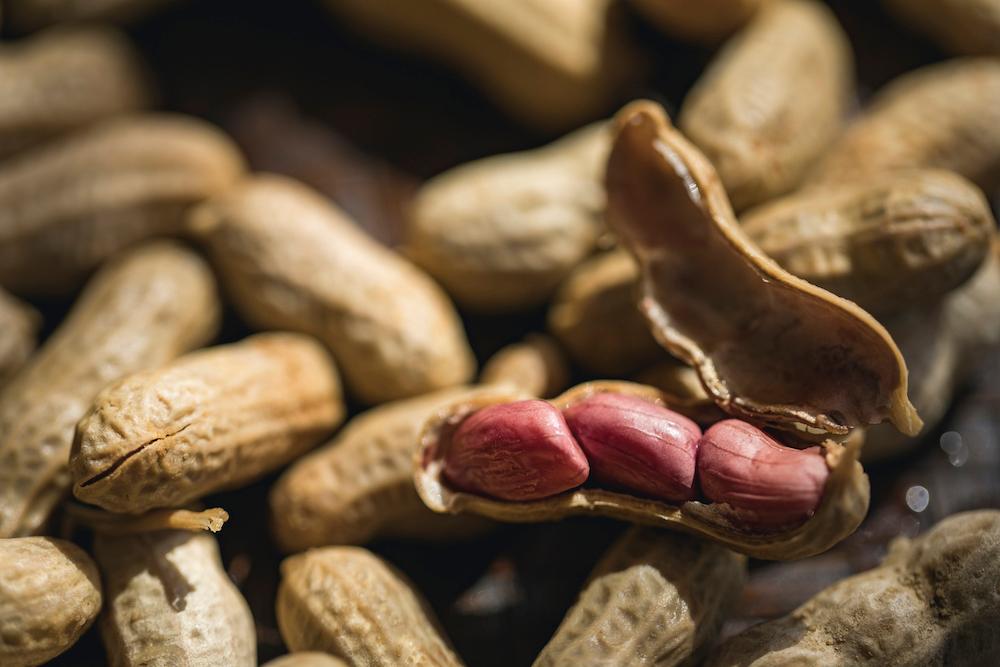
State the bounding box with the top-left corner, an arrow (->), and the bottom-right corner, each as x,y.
0,242 -> 219,537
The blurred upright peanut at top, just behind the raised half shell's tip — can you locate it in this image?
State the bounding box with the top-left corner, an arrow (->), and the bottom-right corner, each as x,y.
680,0 -> 854,211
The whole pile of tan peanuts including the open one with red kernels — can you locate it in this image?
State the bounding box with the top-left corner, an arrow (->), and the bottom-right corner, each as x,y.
0,0 -> 1000,667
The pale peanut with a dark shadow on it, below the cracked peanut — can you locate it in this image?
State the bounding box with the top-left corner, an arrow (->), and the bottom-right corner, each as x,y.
94,531 -> 257,667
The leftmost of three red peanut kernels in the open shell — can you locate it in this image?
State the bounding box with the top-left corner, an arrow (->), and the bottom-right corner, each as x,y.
444,400 -> 590,501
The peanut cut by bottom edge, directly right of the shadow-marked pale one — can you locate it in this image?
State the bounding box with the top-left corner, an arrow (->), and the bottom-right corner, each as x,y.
277,547 -> 462,667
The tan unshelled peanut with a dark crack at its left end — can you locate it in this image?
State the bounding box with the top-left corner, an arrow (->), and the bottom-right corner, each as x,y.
69,333 -> 344,514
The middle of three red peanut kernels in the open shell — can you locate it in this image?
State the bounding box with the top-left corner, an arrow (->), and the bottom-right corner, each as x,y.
563,393 -> 701,502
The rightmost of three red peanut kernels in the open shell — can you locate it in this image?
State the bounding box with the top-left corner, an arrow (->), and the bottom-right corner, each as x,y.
698,419 -> 830,529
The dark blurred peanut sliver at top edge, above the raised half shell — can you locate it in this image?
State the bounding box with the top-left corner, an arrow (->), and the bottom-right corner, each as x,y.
631,0 -> 771,44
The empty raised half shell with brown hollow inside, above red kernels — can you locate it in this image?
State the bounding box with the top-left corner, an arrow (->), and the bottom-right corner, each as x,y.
607,102 -> 920,434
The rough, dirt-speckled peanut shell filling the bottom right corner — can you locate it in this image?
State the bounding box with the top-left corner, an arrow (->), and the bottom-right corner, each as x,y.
707,510 -> 1000,667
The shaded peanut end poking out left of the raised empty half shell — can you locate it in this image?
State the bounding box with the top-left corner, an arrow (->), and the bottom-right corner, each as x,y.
548,249 -> 664,377
